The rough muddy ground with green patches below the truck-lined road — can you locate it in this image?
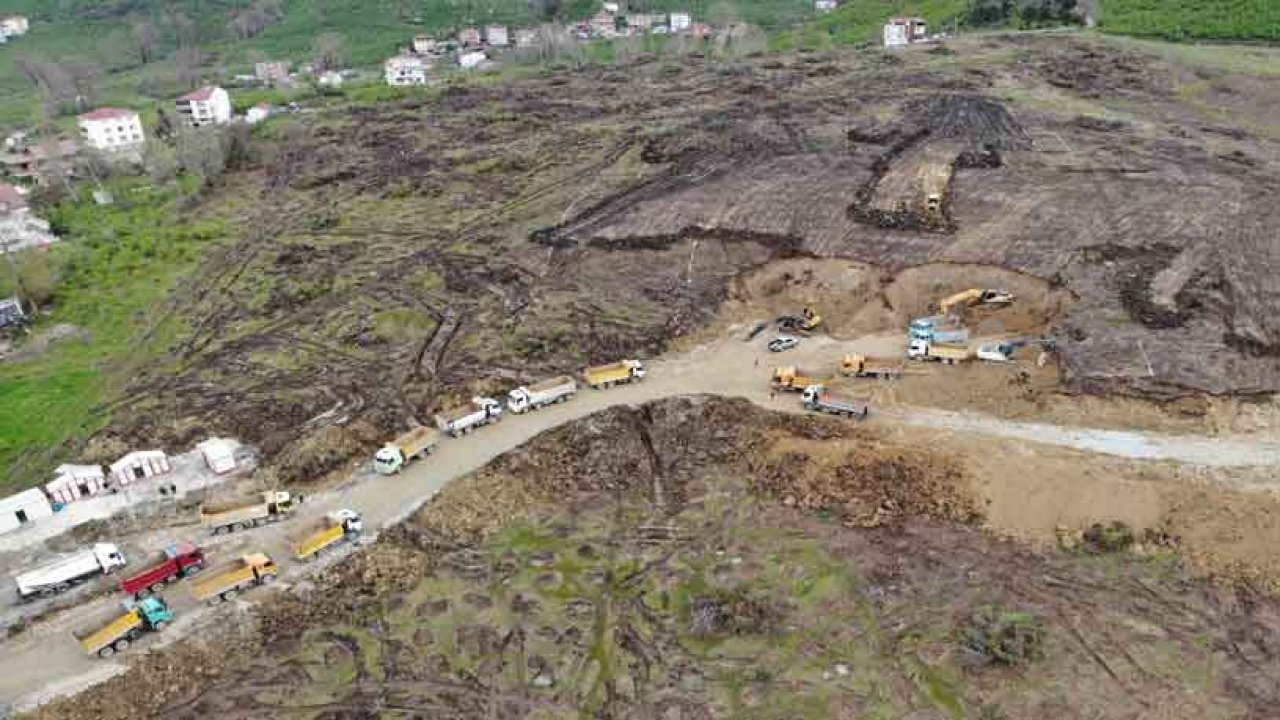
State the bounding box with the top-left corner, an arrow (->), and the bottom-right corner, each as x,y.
30,397 -> 1280,719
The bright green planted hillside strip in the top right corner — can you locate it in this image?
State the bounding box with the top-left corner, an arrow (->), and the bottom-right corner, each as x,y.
1101,0 -> 1280,41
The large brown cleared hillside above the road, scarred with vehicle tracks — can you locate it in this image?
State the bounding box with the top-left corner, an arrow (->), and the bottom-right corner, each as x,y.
82,36 -> 1280,480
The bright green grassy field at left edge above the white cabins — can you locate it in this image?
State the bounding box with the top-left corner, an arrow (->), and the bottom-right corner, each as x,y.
0,178 -> 223,492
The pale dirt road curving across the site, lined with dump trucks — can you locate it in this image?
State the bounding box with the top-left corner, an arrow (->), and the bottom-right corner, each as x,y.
10,328 -> 1280,708
